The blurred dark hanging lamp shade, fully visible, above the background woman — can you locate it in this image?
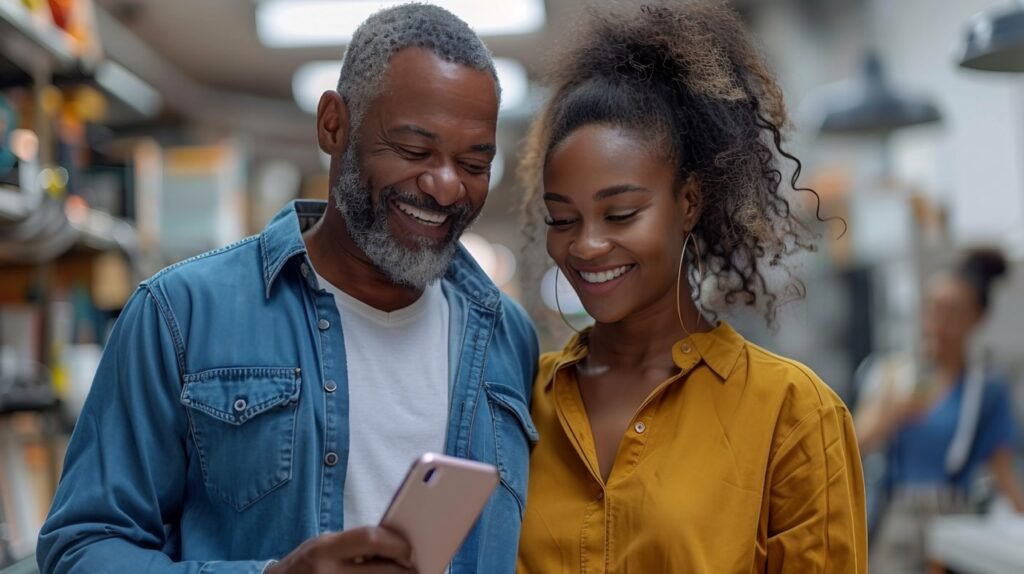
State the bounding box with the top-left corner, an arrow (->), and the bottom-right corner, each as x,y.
821,52 -> 942,135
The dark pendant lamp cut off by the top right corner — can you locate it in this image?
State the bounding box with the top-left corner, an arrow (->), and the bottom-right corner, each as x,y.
959,0 -> 1024,72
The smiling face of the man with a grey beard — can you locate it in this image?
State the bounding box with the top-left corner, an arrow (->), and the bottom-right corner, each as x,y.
332,48 -> 498,288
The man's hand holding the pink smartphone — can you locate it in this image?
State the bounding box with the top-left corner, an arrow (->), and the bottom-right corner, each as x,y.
265,526 -> 415,574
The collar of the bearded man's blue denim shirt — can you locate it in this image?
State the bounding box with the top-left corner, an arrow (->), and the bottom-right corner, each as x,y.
259,200 -> 501,311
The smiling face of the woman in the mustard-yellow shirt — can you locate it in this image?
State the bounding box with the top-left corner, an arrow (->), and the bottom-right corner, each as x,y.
544,124 -> 696,323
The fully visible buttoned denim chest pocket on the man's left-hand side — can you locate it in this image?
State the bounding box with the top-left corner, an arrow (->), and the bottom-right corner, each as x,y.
180,367 -> 301,512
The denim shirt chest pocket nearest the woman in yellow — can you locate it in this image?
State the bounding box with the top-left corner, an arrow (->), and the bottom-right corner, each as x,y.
483,383 -> 539,518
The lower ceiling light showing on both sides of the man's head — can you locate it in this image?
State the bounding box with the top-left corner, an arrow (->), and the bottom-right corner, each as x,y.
292,57 -> 529,114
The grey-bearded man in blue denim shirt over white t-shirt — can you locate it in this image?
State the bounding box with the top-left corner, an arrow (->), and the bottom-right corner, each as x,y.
38,4 -> 538,574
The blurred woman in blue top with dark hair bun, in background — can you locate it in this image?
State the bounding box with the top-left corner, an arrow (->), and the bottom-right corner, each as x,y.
857,250 -> 1024,574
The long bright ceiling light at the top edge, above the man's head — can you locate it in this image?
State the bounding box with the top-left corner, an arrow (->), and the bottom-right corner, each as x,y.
256,0 -> 546,48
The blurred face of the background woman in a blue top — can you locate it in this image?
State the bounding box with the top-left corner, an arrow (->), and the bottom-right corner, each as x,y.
923,275 -> 981,360
